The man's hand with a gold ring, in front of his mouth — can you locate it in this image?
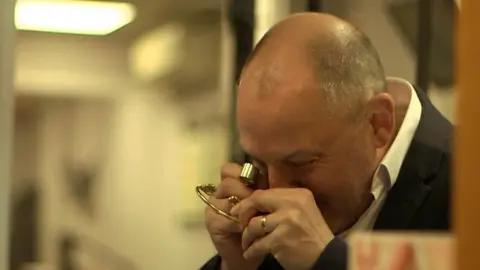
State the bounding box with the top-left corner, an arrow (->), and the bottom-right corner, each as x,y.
231,188 -> 334,270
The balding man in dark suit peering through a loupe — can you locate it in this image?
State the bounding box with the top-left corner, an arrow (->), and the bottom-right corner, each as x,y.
203,13 -> 452,270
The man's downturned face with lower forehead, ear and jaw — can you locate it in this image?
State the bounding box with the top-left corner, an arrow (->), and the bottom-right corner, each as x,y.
237,54 -> 386,233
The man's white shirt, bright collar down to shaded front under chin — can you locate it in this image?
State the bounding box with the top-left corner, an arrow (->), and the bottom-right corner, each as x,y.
340,78 -> 422,238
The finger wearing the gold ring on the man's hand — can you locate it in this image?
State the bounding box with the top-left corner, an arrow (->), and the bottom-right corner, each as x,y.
242,213 -> 280,250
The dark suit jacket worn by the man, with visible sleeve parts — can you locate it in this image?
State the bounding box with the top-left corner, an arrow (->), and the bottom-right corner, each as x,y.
201,89 -> 453,270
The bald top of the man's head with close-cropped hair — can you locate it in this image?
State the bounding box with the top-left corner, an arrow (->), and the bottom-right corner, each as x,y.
240,13 -> 386,118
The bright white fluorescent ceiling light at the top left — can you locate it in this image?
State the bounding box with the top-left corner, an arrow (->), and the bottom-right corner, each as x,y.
15,0 -> 136,36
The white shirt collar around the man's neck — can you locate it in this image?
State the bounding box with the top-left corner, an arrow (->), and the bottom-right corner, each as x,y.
371,78 -> 422,199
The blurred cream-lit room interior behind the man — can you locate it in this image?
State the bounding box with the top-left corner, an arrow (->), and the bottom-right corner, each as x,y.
6,0 -> 454,270
